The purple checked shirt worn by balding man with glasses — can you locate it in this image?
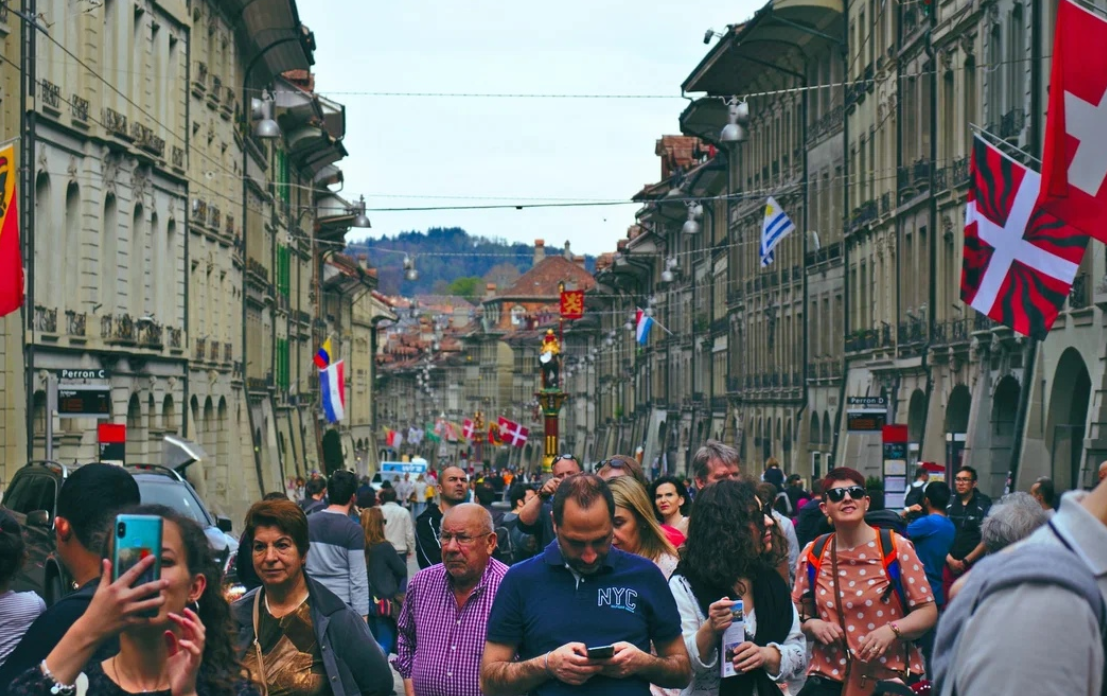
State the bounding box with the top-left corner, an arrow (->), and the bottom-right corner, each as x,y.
392,559 -> 507,696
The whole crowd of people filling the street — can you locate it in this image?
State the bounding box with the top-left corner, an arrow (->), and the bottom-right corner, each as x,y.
0,451 -> 1107,696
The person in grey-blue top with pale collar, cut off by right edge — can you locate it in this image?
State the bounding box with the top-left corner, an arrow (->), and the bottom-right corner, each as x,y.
933,469 -> 1107,696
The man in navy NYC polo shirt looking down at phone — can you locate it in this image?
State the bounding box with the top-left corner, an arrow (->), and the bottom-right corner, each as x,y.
480,474 -> 692,696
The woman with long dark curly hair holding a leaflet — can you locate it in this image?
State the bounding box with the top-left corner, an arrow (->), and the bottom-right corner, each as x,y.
669,480 -> 807,696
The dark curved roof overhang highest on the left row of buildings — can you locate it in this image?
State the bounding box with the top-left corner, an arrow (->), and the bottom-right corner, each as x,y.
221,0 -> 315,84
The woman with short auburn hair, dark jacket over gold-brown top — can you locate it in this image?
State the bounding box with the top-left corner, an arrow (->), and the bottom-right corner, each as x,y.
232,500 -> 393,696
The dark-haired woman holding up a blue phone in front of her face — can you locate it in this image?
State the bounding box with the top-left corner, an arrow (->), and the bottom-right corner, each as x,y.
9,505 -> 257,696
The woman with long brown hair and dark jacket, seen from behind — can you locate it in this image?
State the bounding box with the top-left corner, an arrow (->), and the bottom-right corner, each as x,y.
361,507 -> 407,655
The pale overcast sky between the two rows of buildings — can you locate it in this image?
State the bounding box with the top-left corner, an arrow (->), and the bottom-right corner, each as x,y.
299,0 -> 759,253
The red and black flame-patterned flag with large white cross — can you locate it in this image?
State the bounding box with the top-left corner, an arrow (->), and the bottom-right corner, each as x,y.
961,136 -> 1088,339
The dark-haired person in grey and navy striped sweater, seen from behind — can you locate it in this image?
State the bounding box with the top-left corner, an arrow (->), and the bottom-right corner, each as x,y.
307,471 -> 369,620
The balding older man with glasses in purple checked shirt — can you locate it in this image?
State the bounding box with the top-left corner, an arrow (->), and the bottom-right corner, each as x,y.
392,502 -> 507,696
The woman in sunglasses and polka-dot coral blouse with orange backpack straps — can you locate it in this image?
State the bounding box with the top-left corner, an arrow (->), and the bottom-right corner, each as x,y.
792,468 -> 938,696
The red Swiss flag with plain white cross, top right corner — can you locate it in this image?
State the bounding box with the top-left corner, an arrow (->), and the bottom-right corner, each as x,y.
1042,0 -> 1107,241
